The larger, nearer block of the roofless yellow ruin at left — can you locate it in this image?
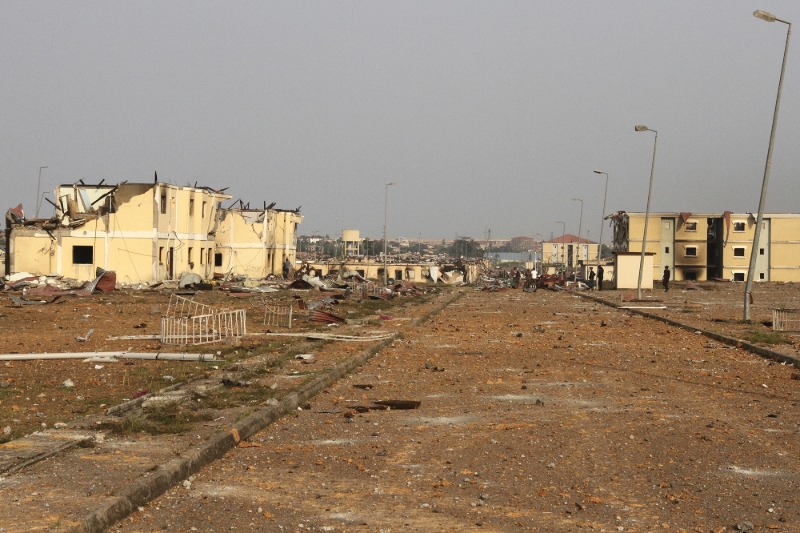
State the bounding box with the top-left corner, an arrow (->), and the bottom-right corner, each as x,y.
9,183 -> 230,282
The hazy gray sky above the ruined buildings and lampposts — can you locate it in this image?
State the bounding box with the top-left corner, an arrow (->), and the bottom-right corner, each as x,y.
0,0 -> 800,240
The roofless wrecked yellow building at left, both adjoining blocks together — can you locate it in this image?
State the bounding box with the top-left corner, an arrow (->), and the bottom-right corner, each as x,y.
5,182 -> 302,283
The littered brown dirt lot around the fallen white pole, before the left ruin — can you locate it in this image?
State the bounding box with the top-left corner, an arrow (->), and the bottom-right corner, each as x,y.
0,290 -> 438,443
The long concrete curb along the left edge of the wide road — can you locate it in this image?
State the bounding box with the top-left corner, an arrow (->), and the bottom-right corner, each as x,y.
75,292 -> 464,533
